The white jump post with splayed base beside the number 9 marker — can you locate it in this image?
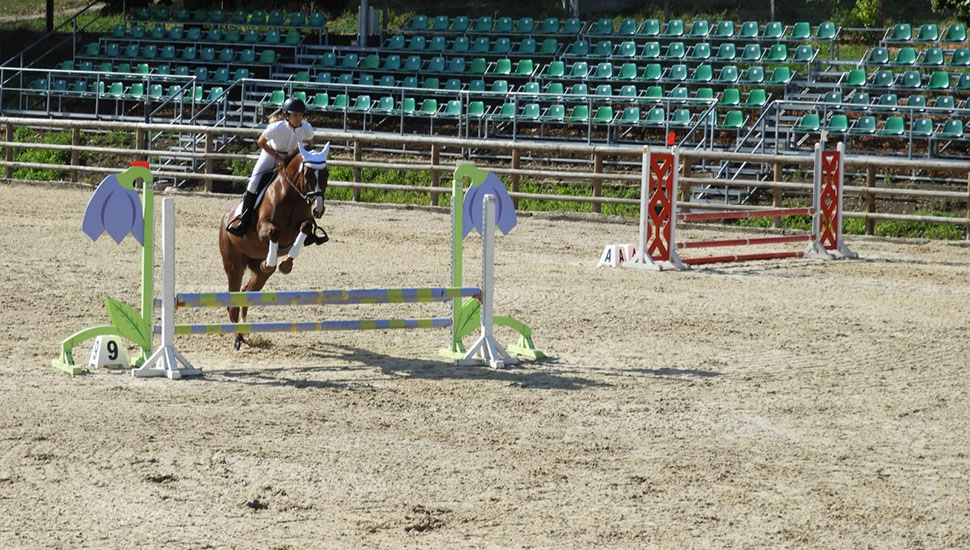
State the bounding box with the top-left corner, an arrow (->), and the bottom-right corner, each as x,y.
131,197 -> 202,380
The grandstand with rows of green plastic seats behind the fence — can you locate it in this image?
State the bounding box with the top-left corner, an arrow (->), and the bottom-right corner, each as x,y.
0,6 -> 970,157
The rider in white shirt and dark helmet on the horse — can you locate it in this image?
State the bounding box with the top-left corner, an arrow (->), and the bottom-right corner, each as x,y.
226,97 -> 313,237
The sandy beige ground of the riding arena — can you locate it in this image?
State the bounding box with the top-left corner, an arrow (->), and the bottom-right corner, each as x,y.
0,185 -> 970,550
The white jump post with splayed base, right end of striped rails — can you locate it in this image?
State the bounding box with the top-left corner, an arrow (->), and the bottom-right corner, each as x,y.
456,195 -> 519,369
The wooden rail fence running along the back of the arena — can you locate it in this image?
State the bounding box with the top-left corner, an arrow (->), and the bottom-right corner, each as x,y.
0,117 -> 970,238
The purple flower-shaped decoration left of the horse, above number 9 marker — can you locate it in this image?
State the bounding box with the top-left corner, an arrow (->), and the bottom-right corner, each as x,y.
81,174 -> 145,246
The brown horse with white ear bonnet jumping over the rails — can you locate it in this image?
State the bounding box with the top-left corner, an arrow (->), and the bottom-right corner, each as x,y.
219,143 -> 330,350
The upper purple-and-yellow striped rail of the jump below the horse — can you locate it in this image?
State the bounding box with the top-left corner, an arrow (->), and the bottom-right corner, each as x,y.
155,287 -> 482,308
